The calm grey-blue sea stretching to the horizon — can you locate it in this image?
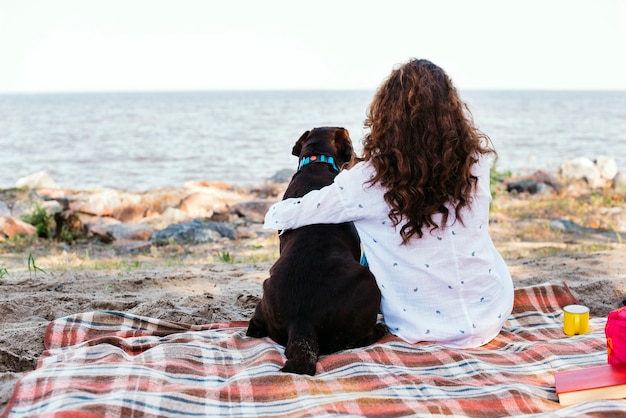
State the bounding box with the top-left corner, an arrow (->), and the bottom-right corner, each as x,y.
0,90 -> 626,191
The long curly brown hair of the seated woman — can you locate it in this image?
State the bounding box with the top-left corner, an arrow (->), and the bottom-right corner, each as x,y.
363,59 -> 495,244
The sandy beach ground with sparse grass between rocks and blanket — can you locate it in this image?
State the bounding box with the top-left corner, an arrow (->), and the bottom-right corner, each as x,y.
0,176 -> 626,409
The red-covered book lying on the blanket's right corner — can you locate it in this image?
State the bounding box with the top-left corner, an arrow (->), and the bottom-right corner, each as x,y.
554,363 -> 626,405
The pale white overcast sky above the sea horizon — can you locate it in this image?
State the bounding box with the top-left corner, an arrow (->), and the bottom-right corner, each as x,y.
0,0 -> 626,93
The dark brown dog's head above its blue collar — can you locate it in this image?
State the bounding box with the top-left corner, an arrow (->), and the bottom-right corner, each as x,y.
291,126 -> 354,167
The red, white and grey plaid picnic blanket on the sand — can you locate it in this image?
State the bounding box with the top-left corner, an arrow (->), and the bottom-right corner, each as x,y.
2,283 -> 626,417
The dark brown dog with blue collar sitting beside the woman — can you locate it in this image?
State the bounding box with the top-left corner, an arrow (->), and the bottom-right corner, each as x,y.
246,127 -> 386,375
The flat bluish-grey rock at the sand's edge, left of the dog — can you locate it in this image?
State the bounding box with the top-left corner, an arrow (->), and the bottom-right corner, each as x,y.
150,219 -> 235,244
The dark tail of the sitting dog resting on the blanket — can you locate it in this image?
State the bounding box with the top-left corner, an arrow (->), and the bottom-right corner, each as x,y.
281,322 -> 320,376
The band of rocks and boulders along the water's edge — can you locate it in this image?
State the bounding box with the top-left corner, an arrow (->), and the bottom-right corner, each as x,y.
0,156 -> 626,247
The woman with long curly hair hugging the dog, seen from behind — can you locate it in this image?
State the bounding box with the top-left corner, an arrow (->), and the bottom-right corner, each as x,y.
265,59 -> 513,348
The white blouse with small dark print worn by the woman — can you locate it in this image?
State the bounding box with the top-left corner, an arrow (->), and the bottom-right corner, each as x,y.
264,158 -> 513,348
